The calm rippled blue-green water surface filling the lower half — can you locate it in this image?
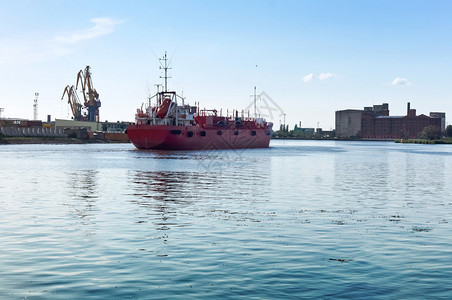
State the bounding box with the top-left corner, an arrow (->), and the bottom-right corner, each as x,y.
0,141 -> 452,299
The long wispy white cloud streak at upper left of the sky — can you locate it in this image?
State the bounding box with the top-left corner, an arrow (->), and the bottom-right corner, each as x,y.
54,18 -> 122,44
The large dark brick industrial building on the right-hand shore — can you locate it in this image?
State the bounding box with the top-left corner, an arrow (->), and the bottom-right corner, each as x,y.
336,103 -> 446,139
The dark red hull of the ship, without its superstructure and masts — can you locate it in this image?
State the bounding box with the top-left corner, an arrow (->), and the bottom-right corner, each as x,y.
127,124 -> 271,150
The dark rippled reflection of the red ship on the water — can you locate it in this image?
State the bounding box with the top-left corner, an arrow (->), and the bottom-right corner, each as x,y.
128,162 -> 271,230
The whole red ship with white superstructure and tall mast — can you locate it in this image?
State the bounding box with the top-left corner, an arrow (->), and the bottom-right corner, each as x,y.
126,54 -> 273,150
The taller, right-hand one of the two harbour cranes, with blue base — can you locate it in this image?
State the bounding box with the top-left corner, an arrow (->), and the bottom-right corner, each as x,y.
75,66 -> 101,122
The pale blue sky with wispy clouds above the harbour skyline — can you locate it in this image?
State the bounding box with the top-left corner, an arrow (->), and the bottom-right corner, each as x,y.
0,0 -> 452,130
